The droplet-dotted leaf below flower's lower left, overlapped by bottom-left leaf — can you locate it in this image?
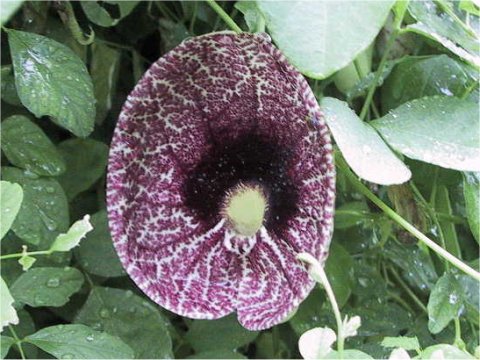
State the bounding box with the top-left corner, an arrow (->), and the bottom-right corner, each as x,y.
75,287 -> 173,359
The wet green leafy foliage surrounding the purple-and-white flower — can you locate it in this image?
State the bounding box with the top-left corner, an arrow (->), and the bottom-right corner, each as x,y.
0,0 -> 480,358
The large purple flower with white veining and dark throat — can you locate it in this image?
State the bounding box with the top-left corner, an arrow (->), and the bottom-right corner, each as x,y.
107,32 -> 335,330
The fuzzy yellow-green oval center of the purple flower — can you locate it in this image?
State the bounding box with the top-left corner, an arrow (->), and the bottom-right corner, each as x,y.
222,184 -> 268,236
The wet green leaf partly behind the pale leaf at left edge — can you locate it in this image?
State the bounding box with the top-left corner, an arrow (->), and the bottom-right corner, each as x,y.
2,167 -> 70,248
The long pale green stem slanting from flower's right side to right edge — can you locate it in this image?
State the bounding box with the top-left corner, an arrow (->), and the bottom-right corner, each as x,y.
337,157 -> 480,282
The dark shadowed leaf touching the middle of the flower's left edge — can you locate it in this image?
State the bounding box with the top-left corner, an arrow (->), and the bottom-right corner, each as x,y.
58,139 -> 108,200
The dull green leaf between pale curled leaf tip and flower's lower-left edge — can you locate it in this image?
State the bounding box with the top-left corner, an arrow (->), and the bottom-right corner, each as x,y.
75,210 -> 125,277
